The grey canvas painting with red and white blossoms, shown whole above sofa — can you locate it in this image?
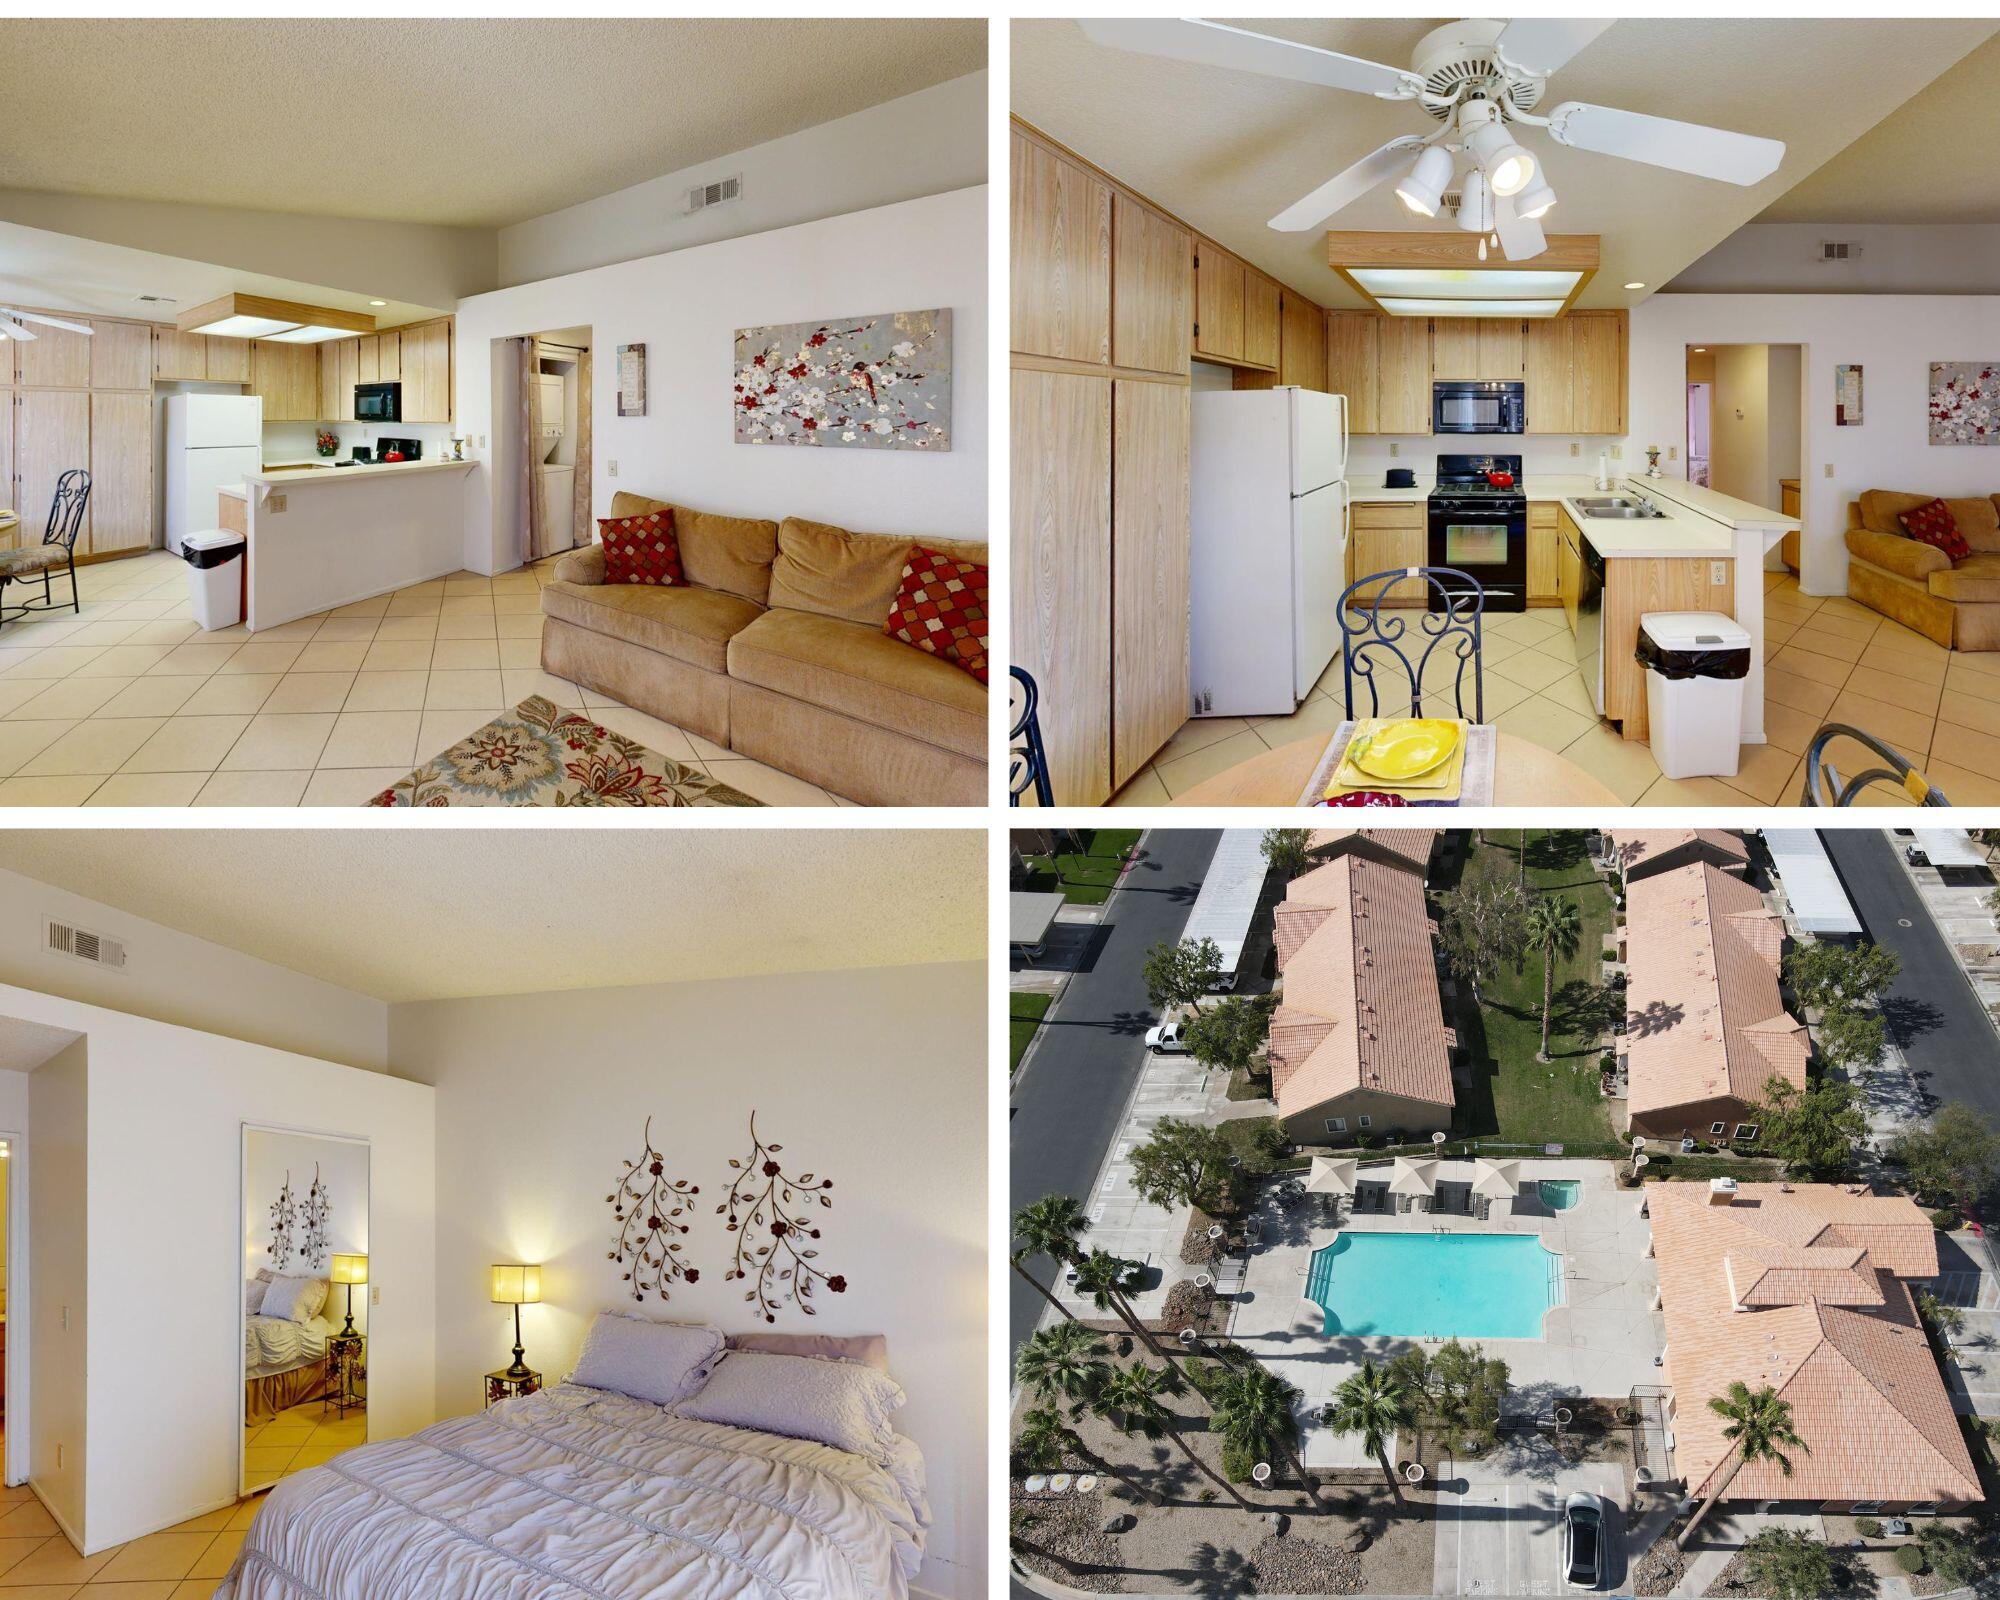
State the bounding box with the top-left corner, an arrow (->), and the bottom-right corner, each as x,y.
732,310 -> 952,452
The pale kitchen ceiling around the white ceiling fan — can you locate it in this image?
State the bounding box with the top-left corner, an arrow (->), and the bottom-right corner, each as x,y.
1010,18 -> 1994,306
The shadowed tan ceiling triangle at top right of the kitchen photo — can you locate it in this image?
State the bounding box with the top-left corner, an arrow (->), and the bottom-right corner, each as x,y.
1758,34 -> 2000,222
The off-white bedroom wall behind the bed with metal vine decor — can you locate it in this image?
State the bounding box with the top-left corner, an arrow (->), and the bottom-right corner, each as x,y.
390,964 -> 988,1600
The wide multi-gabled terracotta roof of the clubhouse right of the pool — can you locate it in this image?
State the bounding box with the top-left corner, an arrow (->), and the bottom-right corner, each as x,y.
1646,1184 -> 1980,1502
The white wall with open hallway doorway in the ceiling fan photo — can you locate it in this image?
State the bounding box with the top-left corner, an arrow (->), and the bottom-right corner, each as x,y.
1624,294 -> 2000,594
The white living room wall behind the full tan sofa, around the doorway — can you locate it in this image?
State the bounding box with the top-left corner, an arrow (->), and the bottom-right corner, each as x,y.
456,186 -> 988,572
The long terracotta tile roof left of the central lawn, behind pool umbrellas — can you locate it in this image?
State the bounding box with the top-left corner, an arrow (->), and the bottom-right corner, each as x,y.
1270,856 -> 1452,1116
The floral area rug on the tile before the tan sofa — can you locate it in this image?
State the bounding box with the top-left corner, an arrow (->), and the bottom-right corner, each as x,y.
368,694 -> 764,806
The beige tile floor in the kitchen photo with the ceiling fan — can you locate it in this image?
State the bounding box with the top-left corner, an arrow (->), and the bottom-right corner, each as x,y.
1112,572 -> 2000,806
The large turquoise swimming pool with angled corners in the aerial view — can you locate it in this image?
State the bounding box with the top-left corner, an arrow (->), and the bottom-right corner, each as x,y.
1306,1232 -> 1562,1338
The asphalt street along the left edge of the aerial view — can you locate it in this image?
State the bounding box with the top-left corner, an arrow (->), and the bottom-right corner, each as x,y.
1008,828 -> 1222,1360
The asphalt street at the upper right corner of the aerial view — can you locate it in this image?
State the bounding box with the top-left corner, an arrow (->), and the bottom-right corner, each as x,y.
1820,828 -> 2000,1128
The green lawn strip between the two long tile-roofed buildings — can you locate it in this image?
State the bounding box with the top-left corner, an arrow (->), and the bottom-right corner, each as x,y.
1452,828 -> 1614,1146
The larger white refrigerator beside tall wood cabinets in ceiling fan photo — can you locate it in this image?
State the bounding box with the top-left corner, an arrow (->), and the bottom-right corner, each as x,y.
1188,388 -> 1350,716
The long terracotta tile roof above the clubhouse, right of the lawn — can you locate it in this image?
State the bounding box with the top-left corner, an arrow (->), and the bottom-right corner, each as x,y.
1626,862 -> 1808,1118
